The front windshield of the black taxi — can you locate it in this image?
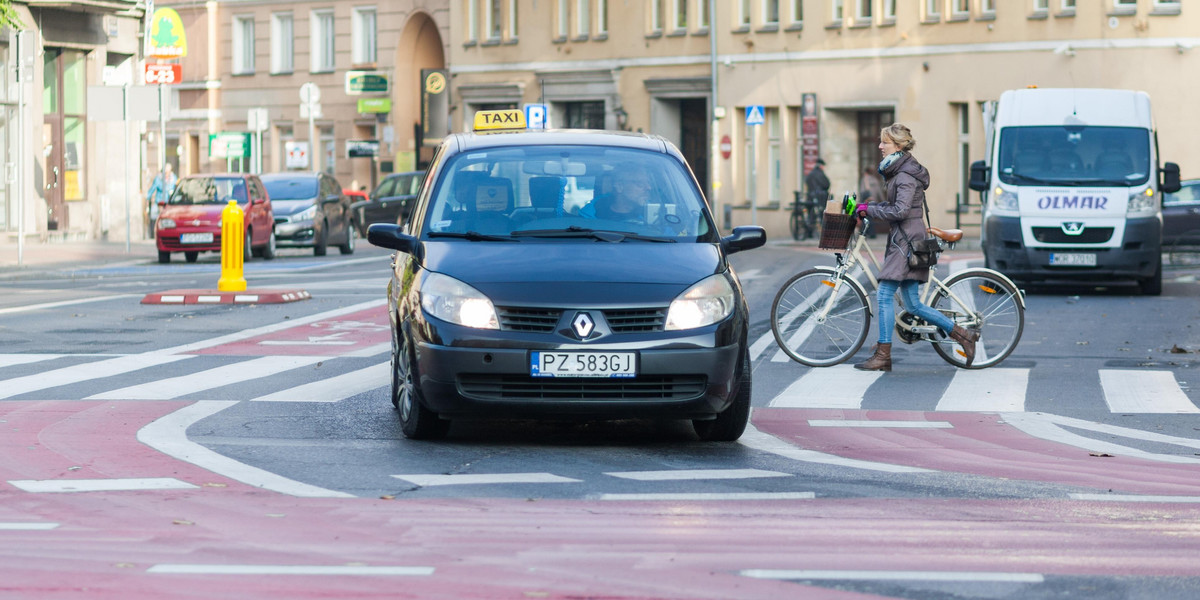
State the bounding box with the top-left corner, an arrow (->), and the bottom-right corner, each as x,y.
421,145 -> 714,242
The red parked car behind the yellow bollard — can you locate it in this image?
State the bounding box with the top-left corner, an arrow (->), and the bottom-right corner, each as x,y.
155,173 -> 275,263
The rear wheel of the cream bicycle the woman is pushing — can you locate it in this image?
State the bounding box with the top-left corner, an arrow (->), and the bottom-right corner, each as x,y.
932,269 -> 1025,368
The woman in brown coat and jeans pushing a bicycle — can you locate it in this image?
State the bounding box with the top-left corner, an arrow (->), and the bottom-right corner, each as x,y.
854,124 -> 979,371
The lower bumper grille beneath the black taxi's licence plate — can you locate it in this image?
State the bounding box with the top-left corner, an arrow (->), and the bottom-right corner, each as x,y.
458,374 -> 707,401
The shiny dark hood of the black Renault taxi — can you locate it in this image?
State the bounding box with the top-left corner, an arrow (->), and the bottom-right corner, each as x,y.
424,240 -> 726,305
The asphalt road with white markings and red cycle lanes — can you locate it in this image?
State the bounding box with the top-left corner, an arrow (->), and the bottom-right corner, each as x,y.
0,244 -> 1200,599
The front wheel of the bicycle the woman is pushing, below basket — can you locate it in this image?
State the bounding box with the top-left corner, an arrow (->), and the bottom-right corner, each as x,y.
770,268 -> 871,367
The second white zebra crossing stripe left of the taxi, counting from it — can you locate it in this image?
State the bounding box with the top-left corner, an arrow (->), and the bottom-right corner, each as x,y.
84,356 -> 325,400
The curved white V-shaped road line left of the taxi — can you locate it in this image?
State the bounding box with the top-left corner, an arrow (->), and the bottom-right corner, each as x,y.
138,401 -> 354,498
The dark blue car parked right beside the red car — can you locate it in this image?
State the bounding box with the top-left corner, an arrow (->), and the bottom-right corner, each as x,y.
262,173 -> 354,257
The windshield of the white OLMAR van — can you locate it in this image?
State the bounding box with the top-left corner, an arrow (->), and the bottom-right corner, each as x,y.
998,126 -> 1152,187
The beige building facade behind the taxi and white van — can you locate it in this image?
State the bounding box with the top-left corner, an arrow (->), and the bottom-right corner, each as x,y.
449,0 -> 1200,238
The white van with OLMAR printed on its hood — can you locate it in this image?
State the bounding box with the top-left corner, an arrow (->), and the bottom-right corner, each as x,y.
970,89 -> 1180,295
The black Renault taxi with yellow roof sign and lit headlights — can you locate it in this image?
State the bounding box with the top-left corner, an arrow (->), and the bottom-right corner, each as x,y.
367,110 -> 767,440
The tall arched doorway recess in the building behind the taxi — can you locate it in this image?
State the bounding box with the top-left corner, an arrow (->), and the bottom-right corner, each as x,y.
391,12 -> 445,172
